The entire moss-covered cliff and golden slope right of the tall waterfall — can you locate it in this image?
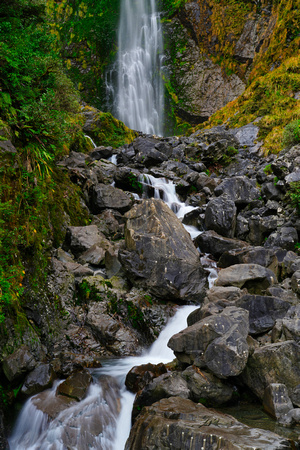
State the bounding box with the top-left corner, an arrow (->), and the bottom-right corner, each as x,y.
165,0 -> 300,152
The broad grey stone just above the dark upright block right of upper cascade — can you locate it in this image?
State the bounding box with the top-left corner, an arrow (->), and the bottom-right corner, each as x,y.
215,176 -> 260,205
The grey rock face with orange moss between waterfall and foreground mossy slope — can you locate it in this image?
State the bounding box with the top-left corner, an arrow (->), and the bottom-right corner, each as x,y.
165,0 -> 277,123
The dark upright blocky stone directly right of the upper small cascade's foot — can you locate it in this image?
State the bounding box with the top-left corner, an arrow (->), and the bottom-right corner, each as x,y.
205,196 -> 237,238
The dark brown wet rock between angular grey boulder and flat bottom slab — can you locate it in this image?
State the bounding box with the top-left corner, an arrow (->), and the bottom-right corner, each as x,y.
182,366 -> 233,406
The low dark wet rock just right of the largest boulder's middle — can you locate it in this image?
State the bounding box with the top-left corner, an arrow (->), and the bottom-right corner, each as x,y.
195,231 -> 249,258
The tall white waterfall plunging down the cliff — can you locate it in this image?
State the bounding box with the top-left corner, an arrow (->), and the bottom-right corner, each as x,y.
107,0 -> 164,136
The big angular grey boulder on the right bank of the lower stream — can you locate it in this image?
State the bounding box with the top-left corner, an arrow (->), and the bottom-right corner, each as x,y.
168,307 -> 249,378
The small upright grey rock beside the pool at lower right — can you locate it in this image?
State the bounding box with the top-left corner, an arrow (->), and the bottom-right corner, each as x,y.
263,383 -> 293,419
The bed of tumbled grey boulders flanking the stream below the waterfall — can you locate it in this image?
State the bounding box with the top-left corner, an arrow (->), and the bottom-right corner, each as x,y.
2,104 -> 300,449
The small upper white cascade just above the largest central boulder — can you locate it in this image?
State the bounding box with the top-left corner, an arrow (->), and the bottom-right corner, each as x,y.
139,174 -> 201,239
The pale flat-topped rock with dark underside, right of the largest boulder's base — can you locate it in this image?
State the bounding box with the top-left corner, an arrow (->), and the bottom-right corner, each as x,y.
216,264 -> 277,294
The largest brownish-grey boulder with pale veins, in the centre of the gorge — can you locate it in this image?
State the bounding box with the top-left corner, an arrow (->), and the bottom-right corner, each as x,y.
119,199 -> 206,302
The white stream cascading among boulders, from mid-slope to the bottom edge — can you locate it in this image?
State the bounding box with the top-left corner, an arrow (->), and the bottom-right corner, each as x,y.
9,175 -> 211,450
